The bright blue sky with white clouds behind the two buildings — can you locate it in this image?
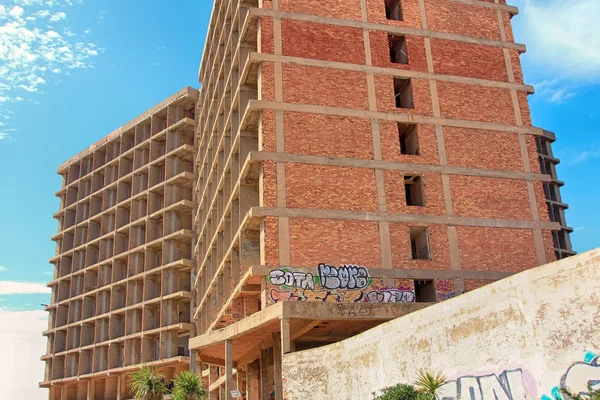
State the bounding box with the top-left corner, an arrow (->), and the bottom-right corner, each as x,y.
0,0 -> 600,399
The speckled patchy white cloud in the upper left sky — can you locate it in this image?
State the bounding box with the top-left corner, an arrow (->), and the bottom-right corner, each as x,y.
0,0 -> 101,140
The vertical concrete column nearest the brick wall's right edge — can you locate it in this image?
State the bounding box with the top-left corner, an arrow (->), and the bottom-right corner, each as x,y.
495,0 -> 548,265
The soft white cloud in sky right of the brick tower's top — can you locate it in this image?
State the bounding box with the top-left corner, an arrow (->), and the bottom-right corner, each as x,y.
514,0 -> 600,103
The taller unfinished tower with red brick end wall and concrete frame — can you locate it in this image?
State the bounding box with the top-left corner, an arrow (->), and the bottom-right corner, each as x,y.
190,0 -> 572,400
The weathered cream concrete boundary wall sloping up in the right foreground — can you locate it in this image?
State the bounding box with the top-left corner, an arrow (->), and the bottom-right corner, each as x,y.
283,249 -> 600,400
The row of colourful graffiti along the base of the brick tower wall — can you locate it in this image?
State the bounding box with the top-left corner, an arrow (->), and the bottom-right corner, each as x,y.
267,264 -> 415,303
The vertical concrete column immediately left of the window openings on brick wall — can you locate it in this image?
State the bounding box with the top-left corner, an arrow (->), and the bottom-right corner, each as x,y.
360,0 -> 394,287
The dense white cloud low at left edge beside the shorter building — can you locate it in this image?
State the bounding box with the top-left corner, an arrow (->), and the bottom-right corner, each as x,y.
0,310 -> 48,400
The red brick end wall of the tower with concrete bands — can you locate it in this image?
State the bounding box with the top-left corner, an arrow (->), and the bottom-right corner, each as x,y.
258,0 -> 554,298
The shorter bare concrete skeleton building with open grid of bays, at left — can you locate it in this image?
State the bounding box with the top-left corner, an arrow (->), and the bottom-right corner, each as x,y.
41,87 -> 198,400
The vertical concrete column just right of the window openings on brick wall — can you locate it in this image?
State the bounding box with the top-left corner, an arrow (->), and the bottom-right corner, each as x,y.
419,0 -> 465,293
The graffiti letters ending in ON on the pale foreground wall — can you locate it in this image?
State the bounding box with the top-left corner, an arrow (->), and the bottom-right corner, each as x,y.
438,369 -> 526,400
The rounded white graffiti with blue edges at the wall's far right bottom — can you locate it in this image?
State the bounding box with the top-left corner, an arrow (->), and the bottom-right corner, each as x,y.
542,351 -> 600,400
